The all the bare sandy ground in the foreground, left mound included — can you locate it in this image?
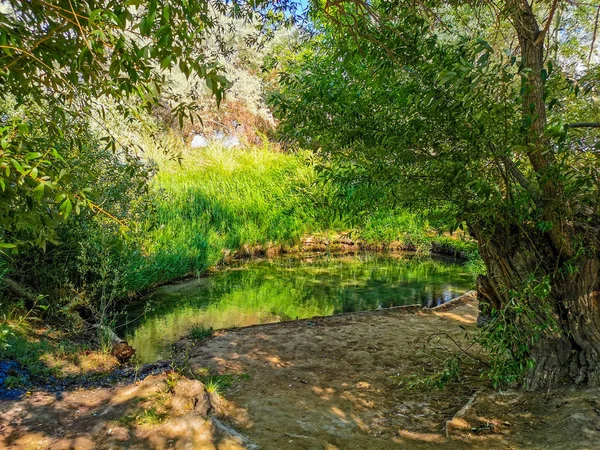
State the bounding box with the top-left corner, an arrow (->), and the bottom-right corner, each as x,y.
0,299 -> 600,450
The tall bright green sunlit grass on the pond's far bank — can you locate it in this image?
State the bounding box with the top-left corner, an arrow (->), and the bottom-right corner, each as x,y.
120,139 -> 341,291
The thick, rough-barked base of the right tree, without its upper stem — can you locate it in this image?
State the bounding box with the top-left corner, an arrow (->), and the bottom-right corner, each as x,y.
471,225 -> 600,389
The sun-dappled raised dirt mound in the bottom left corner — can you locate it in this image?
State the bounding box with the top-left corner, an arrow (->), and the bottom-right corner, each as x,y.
0,374 -> 252,450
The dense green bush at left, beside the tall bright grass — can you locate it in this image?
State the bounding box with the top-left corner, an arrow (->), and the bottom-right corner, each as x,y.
0,103 -> 152,324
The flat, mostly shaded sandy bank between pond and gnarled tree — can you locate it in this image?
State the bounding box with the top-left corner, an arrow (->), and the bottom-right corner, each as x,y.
182,299 -> 600,450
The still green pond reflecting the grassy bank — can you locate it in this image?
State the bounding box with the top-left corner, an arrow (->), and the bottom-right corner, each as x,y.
119,253 -> 473,363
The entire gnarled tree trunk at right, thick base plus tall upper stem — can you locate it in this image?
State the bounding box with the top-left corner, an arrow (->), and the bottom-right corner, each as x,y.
470,0 -> 600,388
